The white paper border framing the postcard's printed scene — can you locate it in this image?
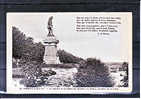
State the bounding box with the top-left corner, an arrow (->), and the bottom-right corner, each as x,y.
6,12 -> 132,94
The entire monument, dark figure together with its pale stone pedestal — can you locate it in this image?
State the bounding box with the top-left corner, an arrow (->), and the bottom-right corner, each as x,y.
43,16 -> 60,64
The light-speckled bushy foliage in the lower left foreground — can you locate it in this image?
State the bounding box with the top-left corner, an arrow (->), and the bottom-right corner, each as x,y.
20,61 -> 56,87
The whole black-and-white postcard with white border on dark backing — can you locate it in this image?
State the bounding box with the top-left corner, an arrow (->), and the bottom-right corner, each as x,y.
6,12 -> 132,94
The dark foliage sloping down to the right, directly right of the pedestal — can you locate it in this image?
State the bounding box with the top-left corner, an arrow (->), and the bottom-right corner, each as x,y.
57,50 -> 83,63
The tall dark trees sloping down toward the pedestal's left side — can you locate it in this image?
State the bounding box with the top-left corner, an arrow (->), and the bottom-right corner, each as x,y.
12,27 -> 44,62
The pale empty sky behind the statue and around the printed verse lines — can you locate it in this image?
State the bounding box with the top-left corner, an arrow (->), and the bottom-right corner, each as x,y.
7,12 -> 131,62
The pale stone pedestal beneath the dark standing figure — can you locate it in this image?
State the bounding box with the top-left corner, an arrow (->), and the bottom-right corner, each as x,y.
44,35 -> 59,64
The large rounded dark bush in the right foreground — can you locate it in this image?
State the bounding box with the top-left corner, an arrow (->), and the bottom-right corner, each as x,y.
76,58 -> 114,87
